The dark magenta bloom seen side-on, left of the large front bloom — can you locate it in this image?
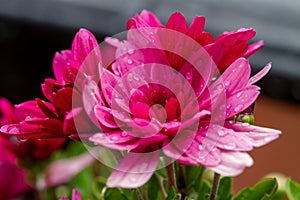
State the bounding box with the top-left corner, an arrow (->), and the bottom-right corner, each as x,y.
1,29 -> 101,139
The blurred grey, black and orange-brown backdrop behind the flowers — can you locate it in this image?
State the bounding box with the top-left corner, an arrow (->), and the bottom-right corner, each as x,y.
0,0 -> 300,190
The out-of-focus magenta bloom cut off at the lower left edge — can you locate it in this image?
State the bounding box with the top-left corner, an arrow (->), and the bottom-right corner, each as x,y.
0,98 -> 30,199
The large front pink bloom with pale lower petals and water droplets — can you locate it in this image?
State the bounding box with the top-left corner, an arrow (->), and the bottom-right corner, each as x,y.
83,20 -> 280,188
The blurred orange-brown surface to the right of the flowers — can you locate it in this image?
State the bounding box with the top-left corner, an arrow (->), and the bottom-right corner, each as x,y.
234,96 -> 300,192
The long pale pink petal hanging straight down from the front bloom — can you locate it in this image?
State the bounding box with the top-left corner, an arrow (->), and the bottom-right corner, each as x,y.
106,151 -> 159,188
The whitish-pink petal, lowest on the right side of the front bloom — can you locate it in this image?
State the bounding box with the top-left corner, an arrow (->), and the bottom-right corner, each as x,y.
209,151 -> 253,176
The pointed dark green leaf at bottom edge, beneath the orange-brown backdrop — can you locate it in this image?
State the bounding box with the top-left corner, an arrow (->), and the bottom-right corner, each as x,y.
234,178 -> 278,200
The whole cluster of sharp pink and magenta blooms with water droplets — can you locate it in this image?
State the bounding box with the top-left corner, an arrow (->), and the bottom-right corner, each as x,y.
0,10 -> 280,192
